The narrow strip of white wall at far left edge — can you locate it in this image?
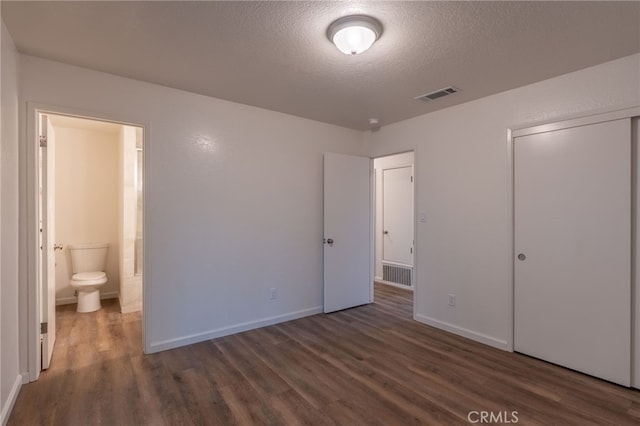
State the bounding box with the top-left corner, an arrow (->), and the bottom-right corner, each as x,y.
0,22 -> 22,424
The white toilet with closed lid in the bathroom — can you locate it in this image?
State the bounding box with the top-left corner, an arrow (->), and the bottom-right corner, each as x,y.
69,244 -> 109,312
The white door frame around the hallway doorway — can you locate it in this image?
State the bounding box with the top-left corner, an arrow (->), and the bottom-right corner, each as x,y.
371,148 -> 419,321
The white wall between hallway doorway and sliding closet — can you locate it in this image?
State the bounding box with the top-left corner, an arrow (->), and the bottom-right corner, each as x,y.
366,55 -> 640,348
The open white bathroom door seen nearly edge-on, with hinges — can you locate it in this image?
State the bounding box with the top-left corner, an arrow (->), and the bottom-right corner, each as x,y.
39,115 -> 56,370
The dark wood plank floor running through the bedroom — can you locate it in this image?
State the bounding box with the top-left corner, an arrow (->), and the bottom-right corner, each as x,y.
9,285 -> 640,426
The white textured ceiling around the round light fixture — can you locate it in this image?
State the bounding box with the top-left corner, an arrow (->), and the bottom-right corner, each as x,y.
2,1 -> 640,130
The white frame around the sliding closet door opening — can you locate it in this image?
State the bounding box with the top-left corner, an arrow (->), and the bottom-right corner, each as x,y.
506,107 -> 640,352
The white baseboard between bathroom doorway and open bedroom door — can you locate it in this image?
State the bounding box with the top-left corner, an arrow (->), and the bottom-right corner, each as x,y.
147,306 -> 322,354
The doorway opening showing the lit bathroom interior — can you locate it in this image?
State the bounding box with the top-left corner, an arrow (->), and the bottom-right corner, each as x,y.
30,111 -> 144,372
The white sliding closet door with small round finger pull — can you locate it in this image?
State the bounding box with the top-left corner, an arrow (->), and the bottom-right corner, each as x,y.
514,119 -> 631,386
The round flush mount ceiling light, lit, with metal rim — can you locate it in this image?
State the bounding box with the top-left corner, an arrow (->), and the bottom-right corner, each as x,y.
327,15 -> 382,55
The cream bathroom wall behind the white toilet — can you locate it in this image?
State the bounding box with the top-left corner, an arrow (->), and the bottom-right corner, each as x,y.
54,124 -> 120,305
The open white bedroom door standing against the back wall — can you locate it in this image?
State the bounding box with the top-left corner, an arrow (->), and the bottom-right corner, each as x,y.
324,153 -> 373,313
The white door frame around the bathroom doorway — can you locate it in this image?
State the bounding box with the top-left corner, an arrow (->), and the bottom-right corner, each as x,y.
20,102 -> 152,382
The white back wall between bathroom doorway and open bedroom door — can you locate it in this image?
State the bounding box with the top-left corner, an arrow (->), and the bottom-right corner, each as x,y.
21,56 -> 362,358
